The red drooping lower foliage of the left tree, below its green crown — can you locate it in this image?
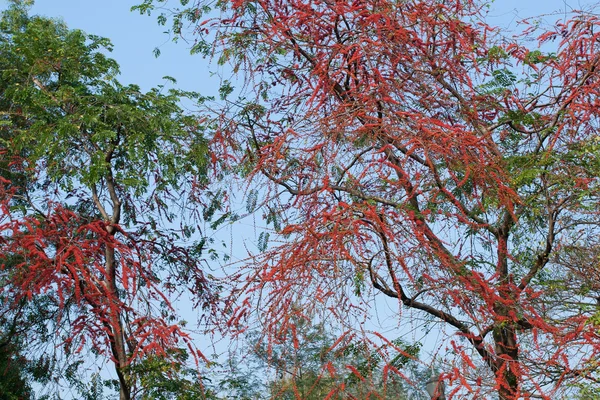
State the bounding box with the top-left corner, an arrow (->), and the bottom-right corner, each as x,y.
0,178 -> 202,367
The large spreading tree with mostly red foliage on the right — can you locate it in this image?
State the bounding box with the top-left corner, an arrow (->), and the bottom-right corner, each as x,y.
138,0 -> 600,400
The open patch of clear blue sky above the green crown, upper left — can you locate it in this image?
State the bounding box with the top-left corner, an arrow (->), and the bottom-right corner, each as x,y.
0,0 -> 218,95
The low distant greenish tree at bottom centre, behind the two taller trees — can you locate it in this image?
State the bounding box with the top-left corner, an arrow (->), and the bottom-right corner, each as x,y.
254,321 -> 428,400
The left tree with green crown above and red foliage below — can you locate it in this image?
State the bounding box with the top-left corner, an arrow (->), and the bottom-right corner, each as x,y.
0,0 -> 217,400
